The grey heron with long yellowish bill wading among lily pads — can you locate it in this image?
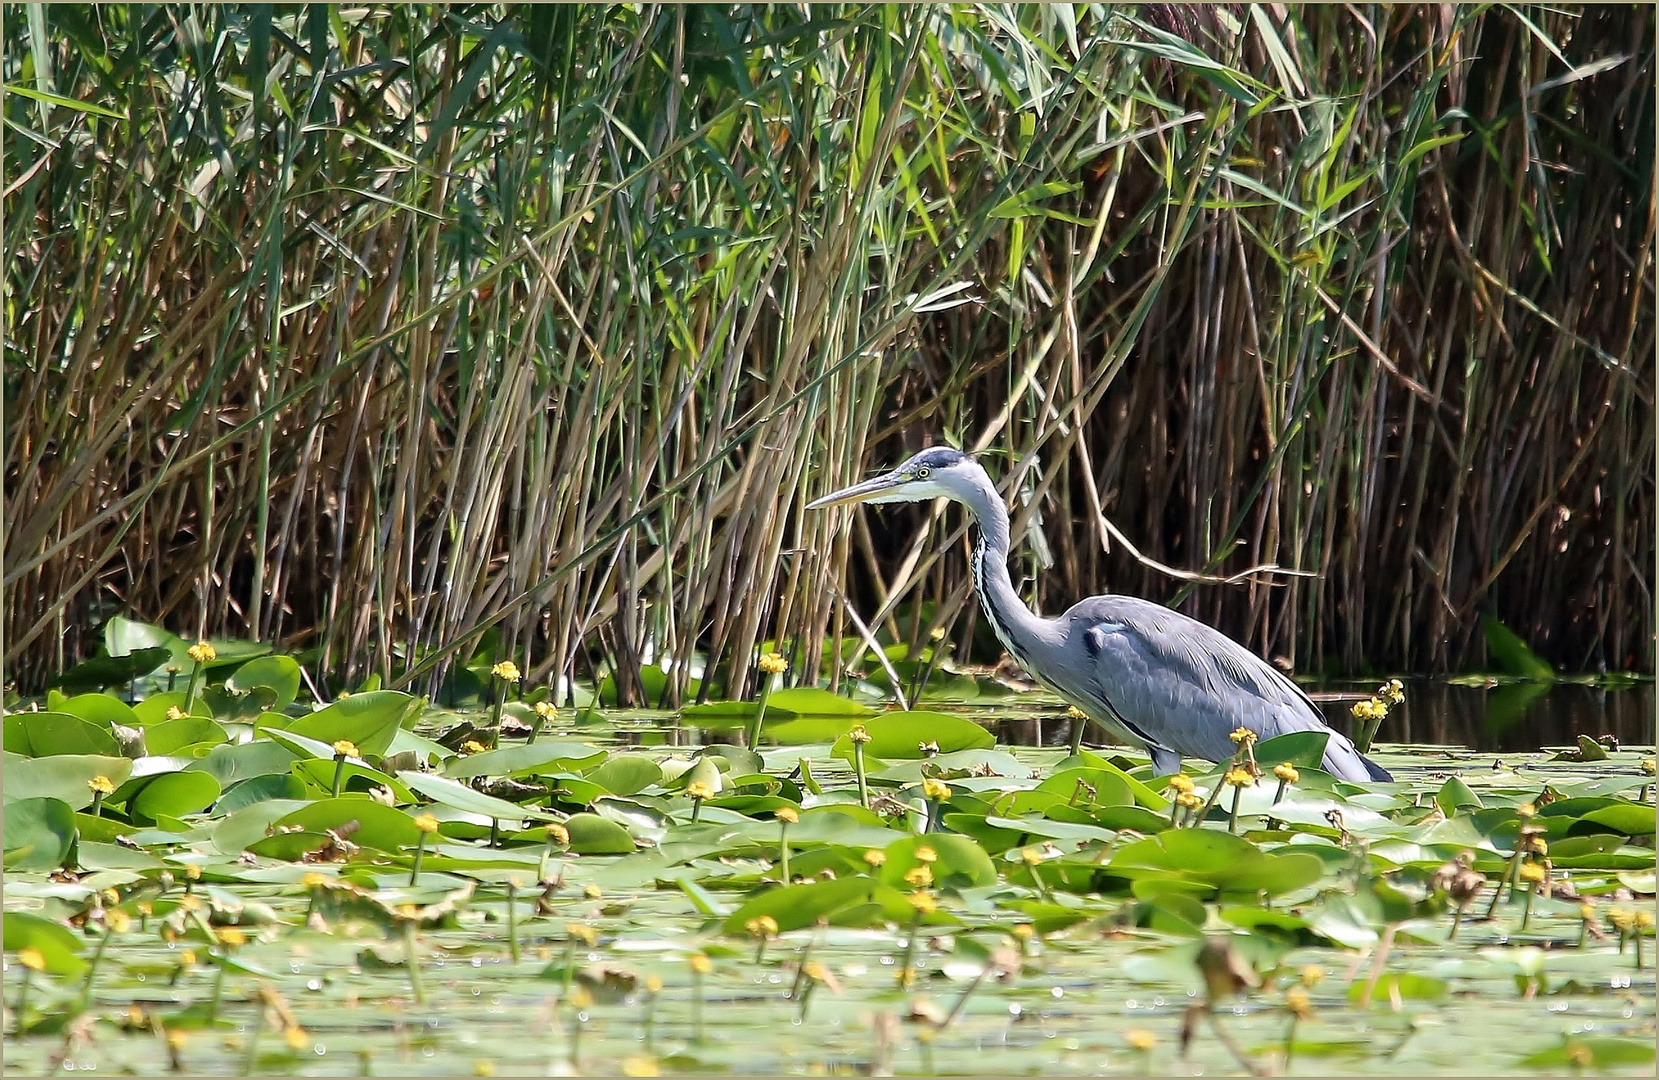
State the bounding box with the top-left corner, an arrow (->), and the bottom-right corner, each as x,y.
806,446 -> 1392,783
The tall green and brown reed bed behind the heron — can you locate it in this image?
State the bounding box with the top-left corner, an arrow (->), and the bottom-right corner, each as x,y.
3,5 -> 1656,705
